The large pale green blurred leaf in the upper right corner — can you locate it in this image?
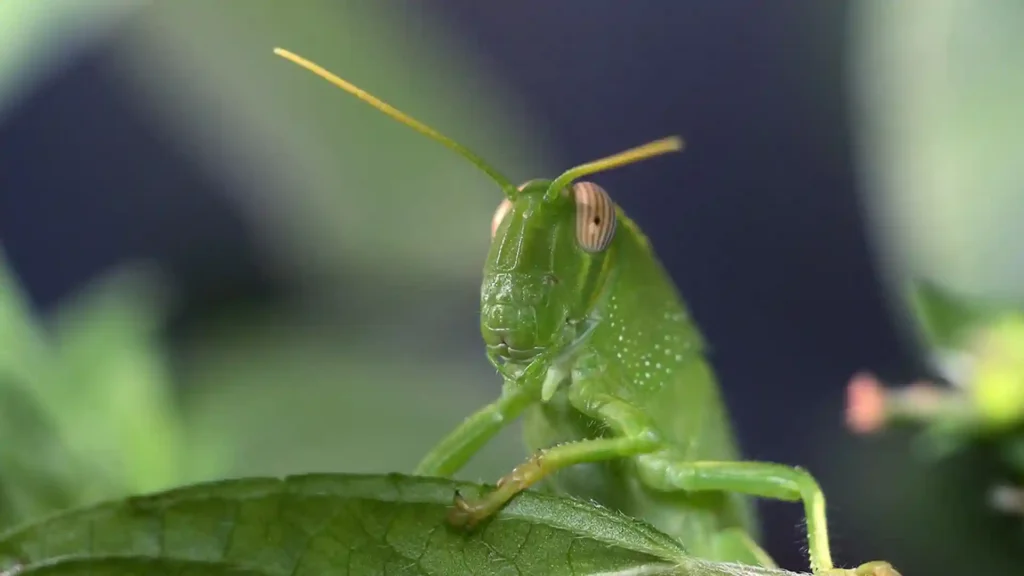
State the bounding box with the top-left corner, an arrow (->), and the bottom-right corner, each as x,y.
851,0 -> 1024,299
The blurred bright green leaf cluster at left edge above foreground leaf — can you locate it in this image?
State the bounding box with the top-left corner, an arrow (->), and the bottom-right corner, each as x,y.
0,249 -> 214,525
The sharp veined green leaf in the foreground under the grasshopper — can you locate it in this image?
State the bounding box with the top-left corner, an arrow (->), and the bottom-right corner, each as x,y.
0,475 -> 793,576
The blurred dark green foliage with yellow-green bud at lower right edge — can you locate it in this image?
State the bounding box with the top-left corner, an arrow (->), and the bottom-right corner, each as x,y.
817,281 -> 1024,575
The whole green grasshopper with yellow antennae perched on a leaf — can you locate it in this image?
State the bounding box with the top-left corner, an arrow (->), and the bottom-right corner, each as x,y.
274,48 -> 897,576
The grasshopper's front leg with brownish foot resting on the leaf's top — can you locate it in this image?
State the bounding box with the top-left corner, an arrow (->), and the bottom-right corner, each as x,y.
449,437 -> 660,527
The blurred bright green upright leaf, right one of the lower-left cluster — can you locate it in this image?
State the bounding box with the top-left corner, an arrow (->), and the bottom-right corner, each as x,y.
48,265 -> 222,497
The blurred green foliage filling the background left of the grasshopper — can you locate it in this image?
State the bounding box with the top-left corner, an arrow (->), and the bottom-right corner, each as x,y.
0,0 -> 563,532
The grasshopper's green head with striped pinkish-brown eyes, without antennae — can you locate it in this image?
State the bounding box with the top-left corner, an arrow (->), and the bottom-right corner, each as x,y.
480,180 -> 616,363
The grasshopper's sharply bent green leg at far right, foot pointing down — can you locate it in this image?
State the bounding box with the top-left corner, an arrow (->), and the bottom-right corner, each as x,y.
639,456 -> 895,576
